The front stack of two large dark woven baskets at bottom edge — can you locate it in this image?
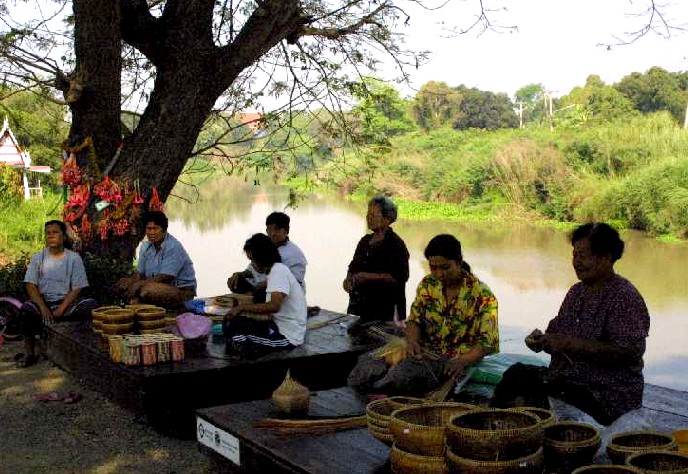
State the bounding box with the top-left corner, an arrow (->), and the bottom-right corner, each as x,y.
446,408 -> 544,474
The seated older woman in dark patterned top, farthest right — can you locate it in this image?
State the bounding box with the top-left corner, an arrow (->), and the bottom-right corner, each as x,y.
492,223 -> 650,425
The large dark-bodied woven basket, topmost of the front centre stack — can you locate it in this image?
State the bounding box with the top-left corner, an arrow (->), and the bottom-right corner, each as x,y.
446,408 -> 543,461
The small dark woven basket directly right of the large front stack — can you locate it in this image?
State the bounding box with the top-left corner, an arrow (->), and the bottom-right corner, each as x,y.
542,421 -> 602,474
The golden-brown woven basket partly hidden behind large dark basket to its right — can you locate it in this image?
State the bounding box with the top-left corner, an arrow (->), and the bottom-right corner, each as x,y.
389,402 -> 474,456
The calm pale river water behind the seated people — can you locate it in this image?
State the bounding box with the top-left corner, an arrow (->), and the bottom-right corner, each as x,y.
167,179 -> 688,391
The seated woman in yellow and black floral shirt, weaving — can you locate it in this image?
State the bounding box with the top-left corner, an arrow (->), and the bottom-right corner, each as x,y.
348,234 -> 499,396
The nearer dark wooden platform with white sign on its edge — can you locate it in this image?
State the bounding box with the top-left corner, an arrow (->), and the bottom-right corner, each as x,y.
197,388 -> 391,474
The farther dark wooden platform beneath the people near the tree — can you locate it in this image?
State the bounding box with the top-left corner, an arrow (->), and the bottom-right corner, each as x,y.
47,310 -> 371,437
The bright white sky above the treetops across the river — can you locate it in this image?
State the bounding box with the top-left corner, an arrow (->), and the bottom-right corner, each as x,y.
385,0 -> 688,97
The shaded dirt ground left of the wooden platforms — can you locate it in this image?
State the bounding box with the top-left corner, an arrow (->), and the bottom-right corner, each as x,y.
0,341 -> 212,474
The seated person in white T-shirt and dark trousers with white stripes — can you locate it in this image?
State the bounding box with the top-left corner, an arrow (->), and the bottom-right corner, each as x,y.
224,234 -> 307,356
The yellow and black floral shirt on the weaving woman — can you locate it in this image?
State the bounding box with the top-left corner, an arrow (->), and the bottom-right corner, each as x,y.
407,272 -> 499,358
